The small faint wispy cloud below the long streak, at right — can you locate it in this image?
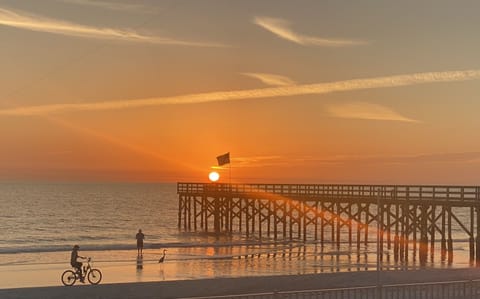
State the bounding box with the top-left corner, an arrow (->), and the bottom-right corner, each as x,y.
326,102 -> 418,122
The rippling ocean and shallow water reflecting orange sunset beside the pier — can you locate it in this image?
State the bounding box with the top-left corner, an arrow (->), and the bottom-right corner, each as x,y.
0,182 -> 469,280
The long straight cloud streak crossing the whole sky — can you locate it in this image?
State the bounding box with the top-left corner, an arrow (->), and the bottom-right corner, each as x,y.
0,70 -> 480,115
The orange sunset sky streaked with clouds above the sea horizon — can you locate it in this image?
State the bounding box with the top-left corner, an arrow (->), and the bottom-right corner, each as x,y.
0,0 -> 480,185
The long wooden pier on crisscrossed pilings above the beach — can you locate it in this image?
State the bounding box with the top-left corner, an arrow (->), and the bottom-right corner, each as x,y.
177,183 -> 480,266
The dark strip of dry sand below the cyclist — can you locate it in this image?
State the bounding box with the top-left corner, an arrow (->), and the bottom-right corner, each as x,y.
0,268 -> 480,299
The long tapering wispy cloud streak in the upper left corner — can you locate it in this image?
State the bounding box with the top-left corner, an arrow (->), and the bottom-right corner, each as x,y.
0,8 -> 221,47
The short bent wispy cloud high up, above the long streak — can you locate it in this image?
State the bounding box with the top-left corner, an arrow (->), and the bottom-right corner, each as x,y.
253,17 -> 366,47
